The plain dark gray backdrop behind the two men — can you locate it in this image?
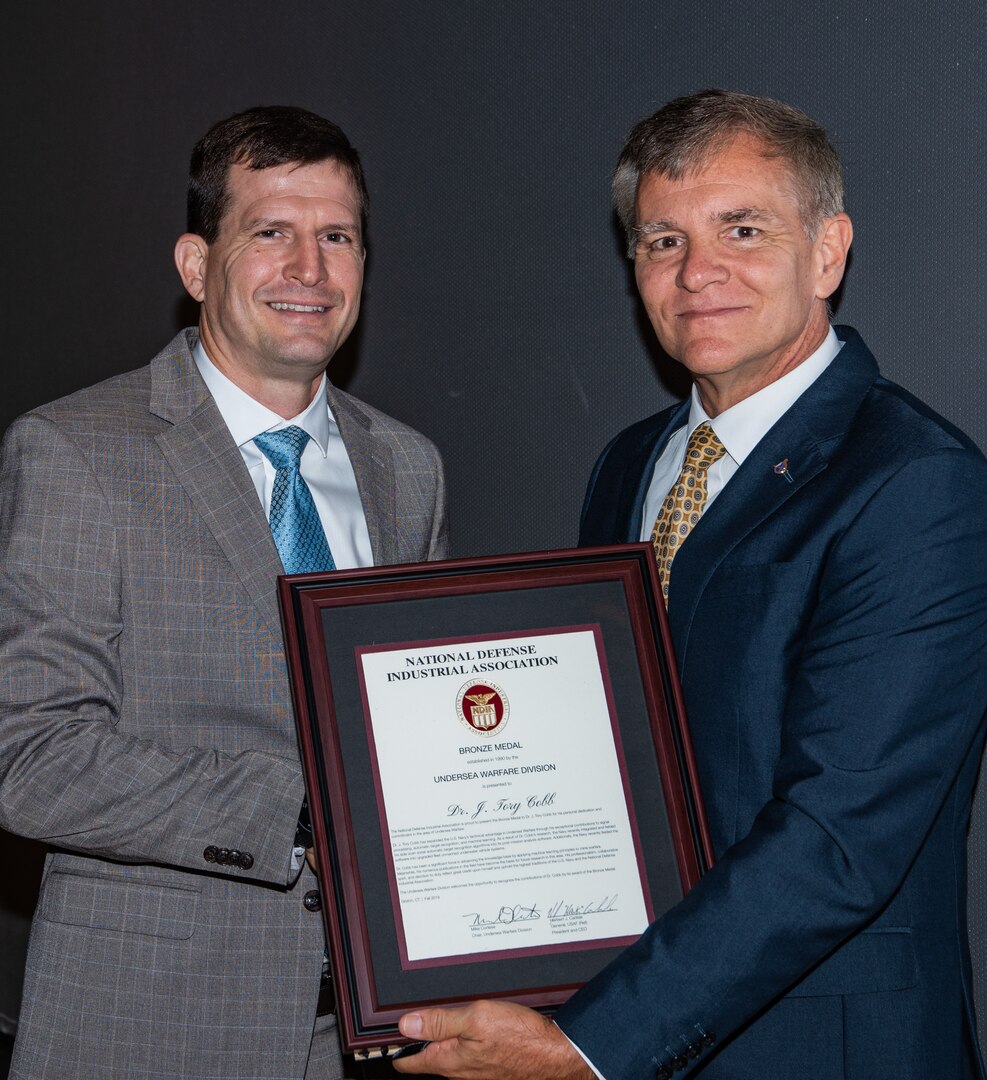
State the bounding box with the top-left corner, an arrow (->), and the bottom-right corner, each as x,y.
0,0 -> 987,1058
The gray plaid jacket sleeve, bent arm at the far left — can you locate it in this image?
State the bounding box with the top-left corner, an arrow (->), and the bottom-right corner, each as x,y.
0,416 -> 303,885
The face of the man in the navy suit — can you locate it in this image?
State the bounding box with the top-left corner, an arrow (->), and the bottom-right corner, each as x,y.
635,135 -> 852,416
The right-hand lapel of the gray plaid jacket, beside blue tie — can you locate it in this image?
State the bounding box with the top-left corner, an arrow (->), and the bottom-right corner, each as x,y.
326,383 -> 397,566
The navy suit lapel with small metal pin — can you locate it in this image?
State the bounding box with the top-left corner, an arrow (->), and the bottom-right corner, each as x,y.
668,326 -> 879,664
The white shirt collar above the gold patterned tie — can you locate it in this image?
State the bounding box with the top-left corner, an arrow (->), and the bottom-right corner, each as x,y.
689,326 -> 843,464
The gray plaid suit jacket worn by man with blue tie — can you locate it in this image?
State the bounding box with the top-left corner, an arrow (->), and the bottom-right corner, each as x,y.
0,330 -> 446,1080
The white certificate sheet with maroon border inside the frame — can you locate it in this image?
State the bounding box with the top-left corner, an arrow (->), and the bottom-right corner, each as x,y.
356,626 -> 651,968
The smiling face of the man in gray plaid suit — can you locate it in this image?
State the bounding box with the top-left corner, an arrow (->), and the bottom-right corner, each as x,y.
175,161 -> 364,416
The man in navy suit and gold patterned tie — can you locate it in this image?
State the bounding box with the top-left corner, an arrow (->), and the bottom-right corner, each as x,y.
398,91 -> 987,1080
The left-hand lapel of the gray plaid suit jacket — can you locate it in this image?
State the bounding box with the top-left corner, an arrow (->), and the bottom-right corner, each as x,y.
151,332 -> 284,636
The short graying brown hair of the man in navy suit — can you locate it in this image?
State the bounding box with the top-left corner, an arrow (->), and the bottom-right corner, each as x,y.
613,90 -> 843,254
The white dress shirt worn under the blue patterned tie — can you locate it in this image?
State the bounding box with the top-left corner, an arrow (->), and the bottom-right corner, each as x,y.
192,341 -> 374,570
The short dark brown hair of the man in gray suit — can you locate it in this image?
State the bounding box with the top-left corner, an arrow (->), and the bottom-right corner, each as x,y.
187,105 -> 369,244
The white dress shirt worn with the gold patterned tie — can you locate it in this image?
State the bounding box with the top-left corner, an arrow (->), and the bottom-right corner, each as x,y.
640,326 -> 843,540
